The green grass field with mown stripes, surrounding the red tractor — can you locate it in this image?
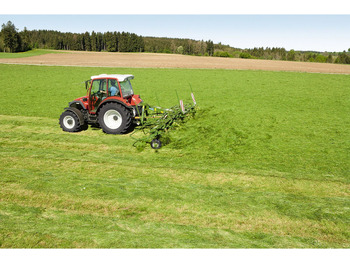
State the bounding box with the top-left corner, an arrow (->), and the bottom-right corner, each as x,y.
0,64 -> 350,248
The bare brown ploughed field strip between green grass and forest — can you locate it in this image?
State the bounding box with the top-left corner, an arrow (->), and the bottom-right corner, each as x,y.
0,51 -> 350,74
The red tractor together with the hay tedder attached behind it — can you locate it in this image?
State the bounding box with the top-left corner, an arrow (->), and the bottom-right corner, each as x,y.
59,74 -> 196,149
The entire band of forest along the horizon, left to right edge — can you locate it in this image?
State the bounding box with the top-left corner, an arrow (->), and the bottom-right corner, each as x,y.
0,21 -> 350,64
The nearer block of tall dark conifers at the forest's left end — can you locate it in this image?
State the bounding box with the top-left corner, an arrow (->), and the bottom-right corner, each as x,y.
0,21 -> 144,52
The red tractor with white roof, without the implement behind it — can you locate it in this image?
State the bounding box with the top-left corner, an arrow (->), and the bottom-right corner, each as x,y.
60,74 -> 142,134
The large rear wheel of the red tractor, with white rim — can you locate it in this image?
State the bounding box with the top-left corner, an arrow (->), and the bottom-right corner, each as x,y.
98,103 -> 132,135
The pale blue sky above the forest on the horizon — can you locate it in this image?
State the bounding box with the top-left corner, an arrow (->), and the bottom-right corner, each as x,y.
0,0 -> 350,52
